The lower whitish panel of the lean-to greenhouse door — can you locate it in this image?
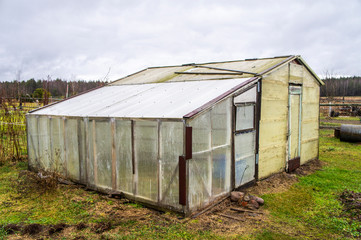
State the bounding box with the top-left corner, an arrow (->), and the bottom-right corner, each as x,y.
234,131 -> 255,187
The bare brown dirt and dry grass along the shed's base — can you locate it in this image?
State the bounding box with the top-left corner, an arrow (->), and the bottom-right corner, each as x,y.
4,160 -> 323,239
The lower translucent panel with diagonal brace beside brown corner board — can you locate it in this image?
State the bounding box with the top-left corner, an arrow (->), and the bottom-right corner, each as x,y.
188,152 -> 212,209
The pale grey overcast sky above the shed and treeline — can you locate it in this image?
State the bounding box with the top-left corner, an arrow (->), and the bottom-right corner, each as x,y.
0,0 -> 361,81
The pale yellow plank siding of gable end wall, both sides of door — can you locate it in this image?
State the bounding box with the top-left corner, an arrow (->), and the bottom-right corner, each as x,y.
259,63 -> 319,179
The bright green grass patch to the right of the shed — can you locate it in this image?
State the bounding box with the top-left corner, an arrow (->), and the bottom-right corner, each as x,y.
263,130 -> 361,239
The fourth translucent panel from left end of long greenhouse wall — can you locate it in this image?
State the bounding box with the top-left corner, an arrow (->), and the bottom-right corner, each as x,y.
65,118 -> 80,180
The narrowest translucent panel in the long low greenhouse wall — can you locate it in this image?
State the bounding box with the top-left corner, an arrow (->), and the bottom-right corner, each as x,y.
85,119 -> 96,185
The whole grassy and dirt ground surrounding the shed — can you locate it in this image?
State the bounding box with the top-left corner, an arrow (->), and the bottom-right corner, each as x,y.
0,104 -> 361,239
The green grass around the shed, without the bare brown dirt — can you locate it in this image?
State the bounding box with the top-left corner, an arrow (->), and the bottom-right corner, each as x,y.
0,130 -> 361,239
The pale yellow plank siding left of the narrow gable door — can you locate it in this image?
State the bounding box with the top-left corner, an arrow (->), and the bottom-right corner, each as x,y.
259,65 -> 289,179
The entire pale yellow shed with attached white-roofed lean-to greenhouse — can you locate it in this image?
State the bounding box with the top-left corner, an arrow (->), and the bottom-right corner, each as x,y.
27,56 -> 323,215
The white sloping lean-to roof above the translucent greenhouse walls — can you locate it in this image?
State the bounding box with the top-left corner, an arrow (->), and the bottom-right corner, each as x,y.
30,78 -> 251,118
